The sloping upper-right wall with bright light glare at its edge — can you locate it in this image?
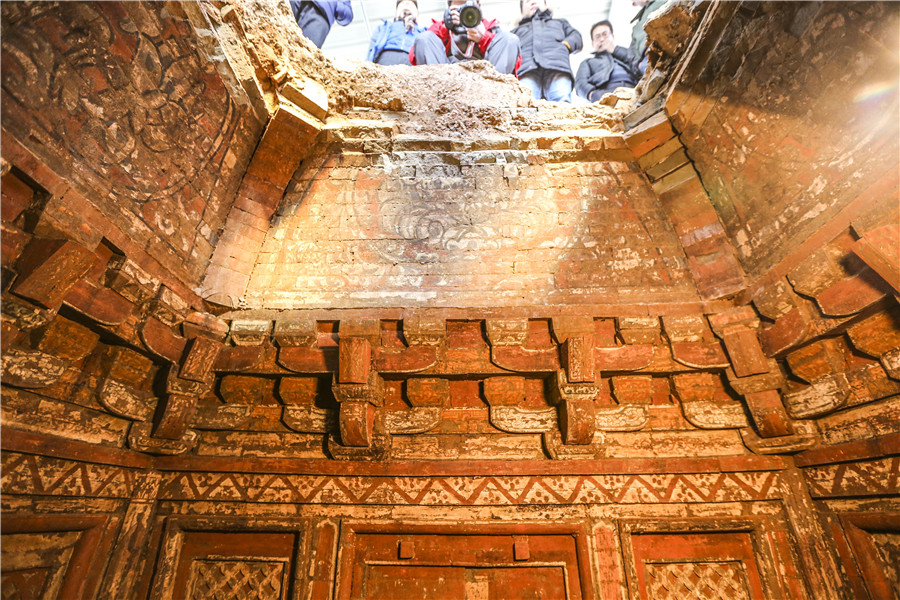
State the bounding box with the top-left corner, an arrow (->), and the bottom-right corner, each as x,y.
665,3 -> 900,278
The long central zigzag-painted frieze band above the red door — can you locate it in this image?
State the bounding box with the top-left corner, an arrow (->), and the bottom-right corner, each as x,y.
159,471 -> 781,506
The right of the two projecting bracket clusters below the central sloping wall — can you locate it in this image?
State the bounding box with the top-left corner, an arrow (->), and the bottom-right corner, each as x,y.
485,316 -> 704,445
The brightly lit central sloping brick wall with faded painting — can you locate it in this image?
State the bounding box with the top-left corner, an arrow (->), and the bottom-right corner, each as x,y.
246,131 -> 696,308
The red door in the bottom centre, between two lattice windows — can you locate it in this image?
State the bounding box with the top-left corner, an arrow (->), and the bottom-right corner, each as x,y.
338,525 -> 592,600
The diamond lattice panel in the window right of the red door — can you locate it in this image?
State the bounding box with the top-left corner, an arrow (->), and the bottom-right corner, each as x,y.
645,561 -> 750,600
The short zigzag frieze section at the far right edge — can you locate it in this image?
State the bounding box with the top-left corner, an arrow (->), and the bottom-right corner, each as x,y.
803,456 -> 900,498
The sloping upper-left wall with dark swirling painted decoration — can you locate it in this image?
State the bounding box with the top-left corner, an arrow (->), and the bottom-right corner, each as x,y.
3,2 -> 263,284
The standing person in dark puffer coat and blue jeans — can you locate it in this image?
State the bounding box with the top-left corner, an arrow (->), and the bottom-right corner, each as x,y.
512,0 -> 581,102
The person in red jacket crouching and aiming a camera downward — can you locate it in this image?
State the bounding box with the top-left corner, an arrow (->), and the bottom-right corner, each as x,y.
409,0 -> 522,73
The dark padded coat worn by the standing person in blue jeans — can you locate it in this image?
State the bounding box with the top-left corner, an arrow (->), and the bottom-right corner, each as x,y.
512,10 -> 581,77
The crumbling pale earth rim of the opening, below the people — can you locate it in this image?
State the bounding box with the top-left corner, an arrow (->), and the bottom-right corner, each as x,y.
220,0 -> 634,138
